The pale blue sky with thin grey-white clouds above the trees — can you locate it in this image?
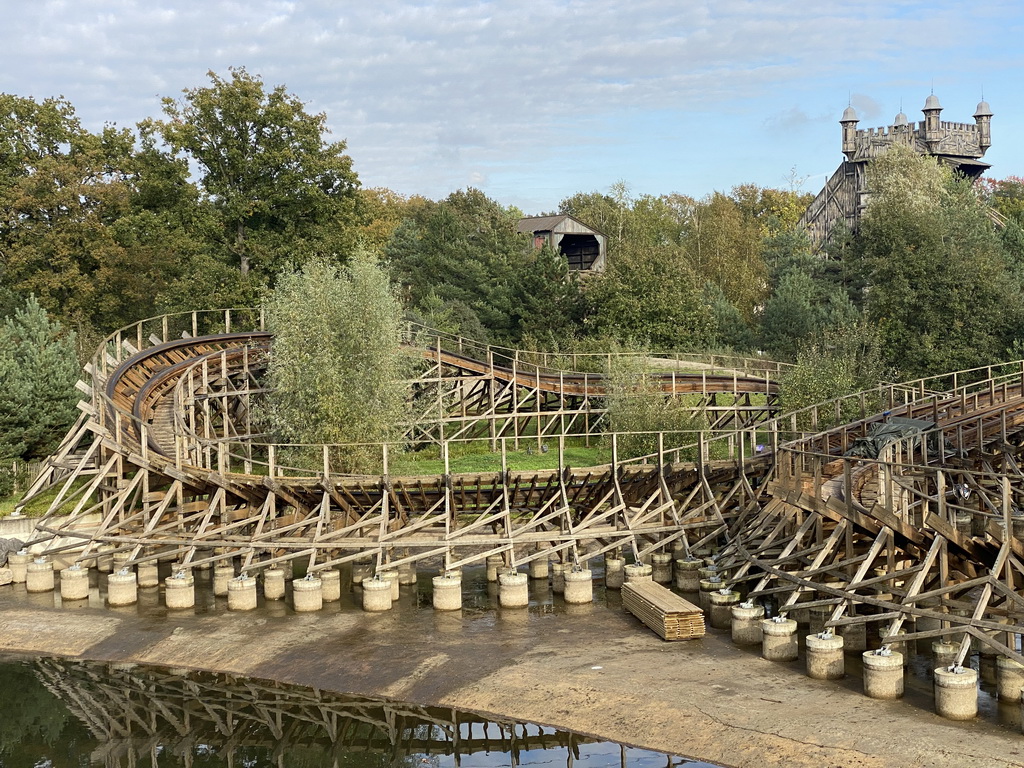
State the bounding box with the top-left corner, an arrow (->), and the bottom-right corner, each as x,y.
0,0 -> 1024,214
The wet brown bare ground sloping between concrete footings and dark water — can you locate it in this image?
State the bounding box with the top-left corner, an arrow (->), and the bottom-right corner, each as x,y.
0,585 -> 1024,768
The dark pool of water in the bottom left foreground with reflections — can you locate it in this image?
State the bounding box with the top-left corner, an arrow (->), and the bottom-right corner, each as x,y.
0,659 -> 710,768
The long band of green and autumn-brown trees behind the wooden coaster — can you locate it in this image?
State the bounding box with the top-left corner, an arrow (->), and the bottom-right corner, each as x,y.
0,68 -> 1024,457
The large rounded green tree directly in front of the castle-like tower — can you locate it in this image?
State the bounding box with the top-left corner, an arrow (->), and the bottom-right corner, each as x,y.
855,146 -> 1022,376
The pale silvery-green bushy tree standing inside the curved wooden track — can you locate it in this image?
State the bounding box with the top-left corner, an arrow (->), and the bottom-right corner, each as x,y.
262,253 -> 406,472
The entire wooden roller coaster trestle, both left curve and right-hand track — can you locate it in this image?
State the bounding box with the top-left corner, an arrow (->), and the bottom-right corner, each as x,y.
14,312 -> 1024,663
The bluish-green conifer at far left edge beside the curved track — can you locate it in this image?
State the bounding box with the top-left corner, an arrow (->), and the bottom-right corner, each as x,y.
0,297 -> 79,459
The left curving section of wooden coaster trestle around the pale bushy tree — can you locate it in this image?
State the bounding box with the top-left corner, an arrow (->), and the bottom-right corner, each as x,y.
16,312 -> 775,571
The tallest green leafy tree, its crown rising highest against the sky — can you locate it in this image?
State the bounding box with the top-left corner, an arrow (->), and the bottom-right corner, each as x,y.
146,68 -> 358,275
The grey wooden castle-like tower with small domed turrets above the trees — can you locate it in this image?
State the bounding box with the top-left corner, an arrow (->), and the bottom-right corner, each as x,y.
800,93 -> 992,248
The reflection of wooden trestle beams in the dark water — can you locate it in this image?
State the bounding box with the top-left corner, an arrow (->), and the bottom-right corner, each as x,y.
35,658 -> 626,768
